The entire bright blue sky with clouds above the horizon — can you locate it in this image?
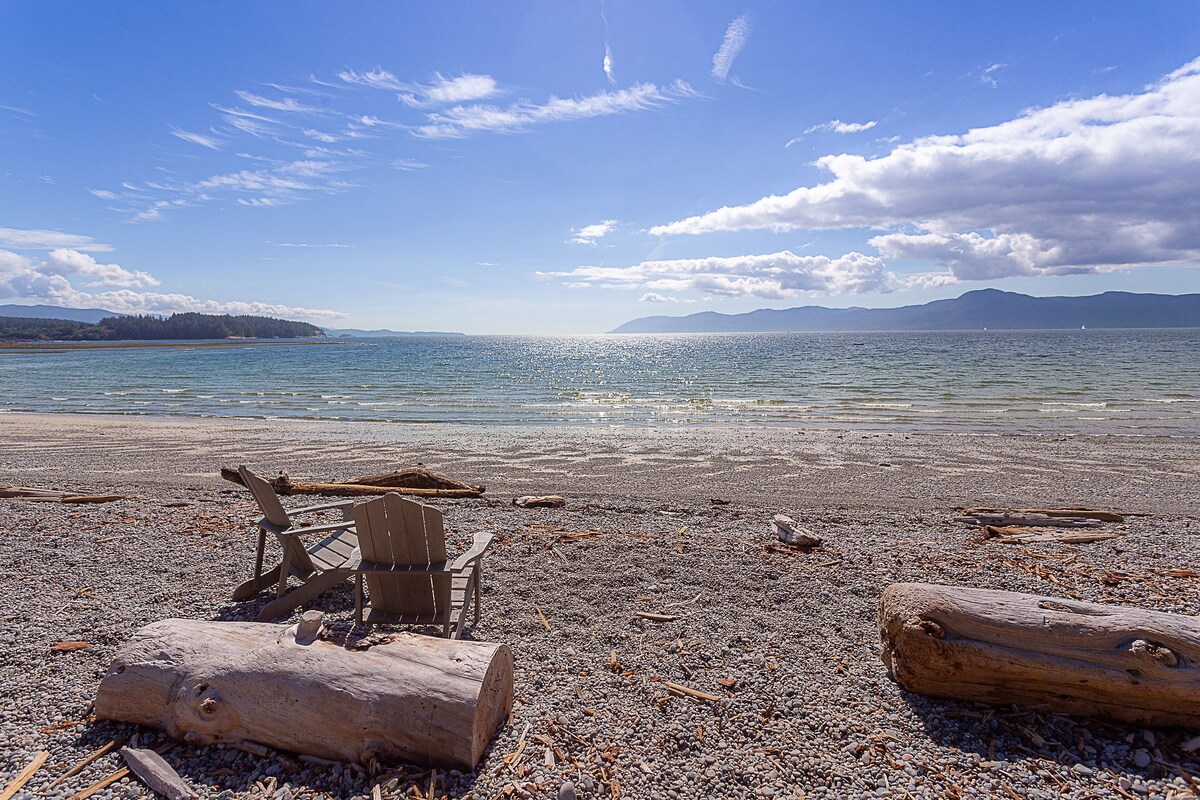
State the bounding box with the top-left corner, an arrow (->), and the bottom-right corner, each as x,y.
0,0 -> 1200,333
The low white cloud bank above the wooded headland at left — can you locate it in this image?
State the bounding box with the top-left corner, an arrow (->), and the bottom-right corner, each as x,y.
0,249 -> 347,319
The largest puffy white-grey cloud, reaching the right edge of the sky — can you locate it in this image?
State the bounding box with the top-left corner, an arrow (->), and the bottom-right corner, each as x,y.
650,59 -> 1200,279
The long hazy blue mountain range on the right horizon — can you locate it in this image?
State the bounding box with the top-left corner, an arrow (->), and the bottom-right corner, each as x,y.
611,289 -> 1200,333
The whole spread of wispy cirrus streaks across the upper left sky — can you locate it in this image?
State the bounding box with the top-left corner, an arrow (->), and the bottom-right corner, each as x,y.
104,67 -> 697,222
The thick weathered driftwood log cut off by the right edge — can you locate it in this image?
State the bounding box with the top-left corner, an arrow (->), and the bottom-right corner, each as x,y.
880,583 -> 1200,729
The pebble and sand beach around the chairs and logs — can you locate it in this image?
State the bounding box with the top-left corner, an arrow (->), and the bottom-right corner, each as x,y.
0,414 -> 1200,800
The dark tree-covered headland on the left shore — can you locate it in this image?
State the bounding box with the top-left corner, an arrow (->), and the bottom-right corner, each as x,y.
0,312 -> 325,342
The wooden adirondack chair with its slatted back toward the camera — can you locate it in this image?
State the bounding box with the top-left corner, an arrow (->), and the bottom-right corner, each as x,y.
354,492 -> 492,639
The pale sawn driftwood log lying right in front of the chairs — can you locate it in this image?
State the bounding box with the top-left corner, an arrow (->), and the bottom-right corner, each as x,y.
96,619 -> 512,770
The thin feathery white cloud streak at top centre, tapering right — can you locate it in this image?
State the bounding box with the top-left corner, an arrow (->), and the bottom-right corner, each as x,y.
414,80 -> 696,139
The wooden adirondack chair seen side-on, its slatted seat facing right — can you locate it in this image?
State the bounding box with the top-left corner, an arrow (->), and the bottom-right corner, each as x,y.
233,467 -> 359,622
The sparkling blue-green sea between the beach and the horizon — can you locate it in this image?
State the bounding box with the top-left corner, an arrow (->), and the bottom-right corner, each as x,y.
0,330 -> 1200,437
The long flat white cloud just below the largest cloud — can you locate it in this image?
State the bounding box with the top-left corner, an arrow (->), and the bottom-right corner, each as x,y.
539,249 -> 901,300
